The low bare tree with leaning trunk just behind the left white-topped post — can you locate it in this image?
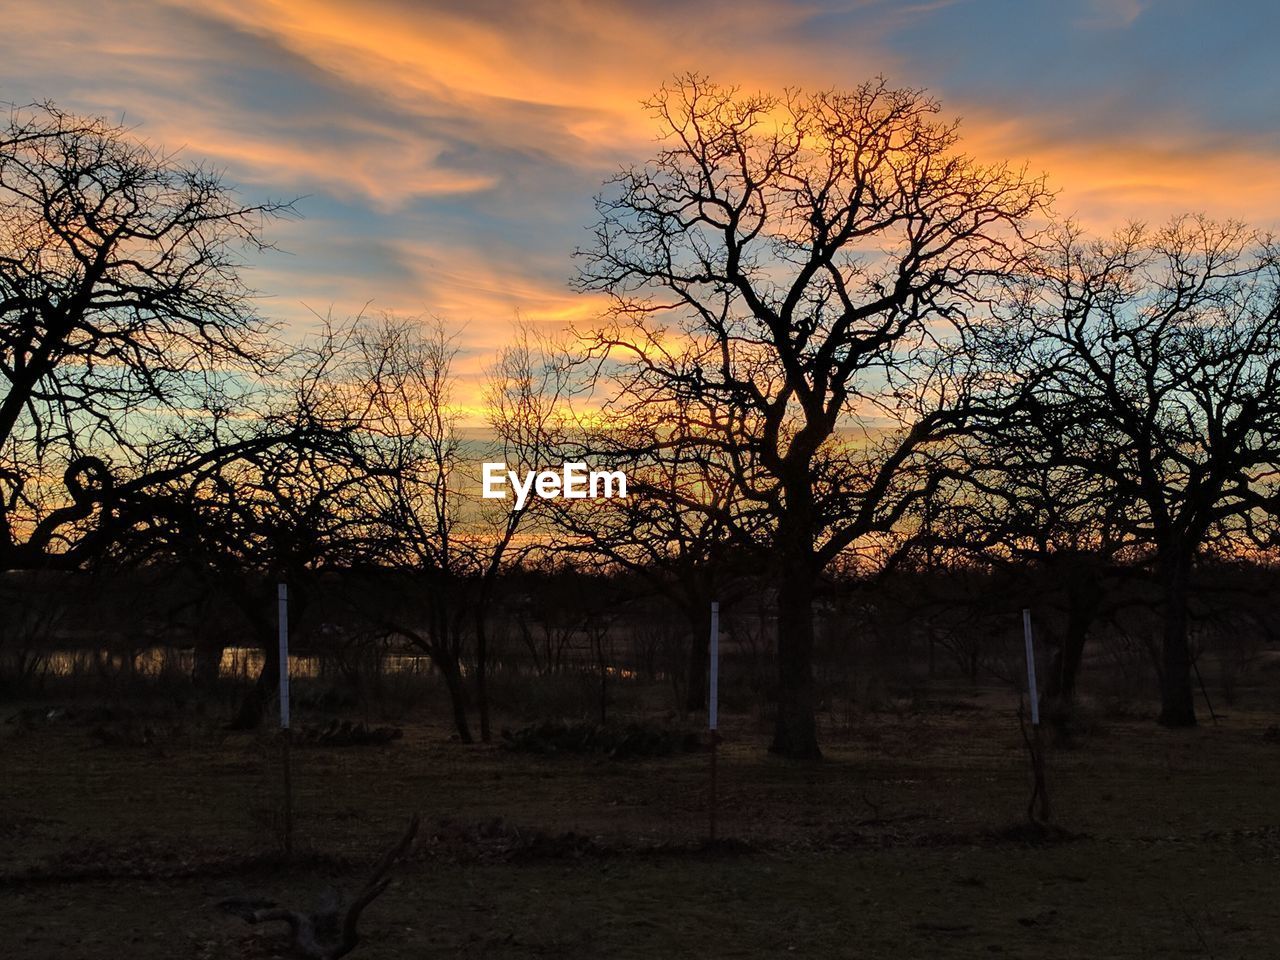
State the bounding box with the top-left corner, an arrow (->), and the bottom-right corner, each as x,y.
97,321 -> 384,728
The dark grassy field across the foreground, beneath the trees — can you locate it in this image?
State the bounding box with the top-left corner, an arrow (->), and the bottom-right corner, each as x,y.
0,690 -> 1280,960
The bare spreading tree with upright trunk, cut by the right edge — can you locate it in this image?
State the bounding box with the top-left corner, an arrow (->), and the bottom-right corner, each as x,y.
975,218 -> 1280,726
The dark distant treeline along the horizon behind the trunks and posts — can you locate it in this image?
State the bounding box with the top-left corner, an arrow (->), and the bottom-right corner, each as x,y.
0,558 -> 1280,737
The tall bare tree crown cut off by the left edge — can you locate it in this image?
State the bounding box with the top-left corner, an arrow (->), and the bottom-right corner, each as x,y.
0,104 -> 287,567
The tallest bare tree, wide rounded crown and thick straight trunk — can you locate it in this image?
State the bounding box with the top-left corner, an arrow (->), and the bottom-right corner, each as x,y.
580,77 -> 1046,758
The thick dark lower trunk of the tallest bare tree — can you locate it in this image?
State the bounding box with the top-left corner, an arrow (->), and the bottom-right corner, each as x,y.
769,562 -> 822,760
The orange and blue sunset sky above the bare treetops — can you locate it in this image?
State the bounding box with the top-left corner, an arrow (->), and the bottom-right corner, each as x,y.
0,0 -> 1280,407
